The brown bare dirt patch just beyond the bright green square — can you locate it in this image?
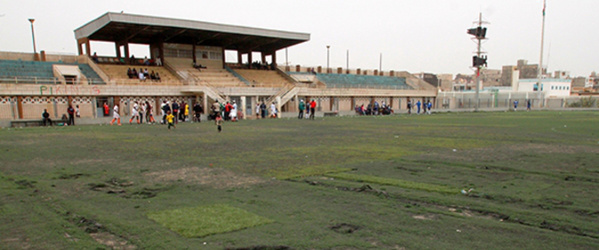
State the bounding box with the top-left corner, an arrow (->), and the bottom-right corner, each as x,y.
144,167 -> 265,189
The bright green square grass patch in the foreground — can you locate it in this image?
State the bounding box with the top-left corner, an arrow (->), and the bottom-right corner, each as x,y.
148,205 -> 273,238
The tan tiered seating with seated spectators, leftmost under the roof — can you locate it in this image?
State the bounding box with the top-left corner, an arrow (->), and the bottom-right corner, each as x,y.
98,64 -> 181,85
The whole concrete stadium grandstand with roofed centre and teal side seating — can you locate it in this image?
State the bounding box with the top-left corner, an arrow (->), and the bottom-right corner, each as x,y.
0,12 -> 437,126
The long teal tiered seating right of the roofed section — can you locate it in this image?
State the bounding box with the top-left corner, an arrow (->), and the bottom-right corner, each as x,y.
316,74 -> 412,89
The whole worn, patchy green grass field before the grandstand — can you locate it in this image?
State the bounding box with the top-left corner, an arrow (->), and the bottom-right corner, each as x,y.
0,112 -> 599,249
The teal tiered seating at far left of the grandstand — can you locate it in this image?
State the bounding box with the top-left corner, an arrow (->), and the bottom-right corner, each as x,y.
0,60 -> 104,84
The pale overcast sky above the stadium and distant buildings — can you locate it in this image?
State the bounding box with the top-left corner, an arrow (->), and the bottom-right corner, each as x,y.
0,0 -> 599,76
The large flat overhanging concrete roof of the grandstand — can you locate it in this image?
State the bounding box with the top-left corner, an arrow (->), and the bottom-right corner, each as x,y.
75,12 -> 310,52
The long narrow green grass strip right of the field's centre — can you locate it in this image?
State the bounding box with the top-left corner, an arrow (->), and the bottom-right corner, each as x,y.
326,173 -> 460,194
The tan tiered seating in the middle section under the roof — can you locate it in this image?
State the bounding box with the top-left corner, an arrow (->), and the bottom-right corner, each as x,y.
166,57 -> 247,87
